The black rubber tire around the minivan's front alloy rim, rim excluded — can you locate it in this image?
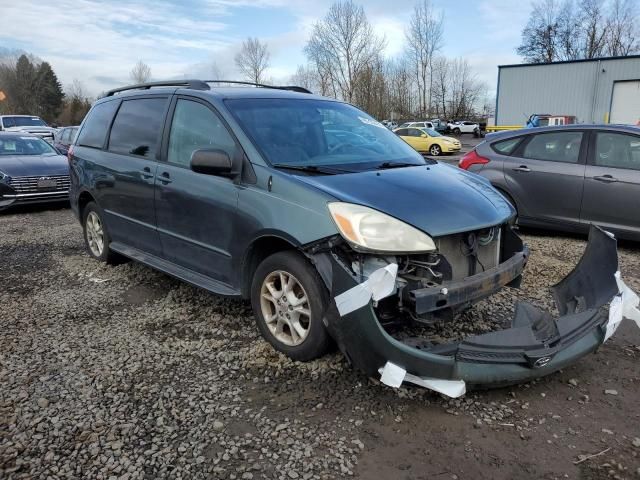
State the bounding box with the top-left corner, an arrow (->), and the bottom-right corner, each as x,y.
251,251 -> 331,362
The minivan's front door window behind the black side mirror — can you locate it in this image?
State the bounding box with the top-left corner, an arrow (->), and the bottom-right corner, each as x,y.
167,99 -> 237,167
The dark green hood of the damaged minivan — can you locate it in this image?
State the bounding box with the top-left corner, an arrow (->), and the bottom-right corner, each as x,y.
297,163 -> 515,237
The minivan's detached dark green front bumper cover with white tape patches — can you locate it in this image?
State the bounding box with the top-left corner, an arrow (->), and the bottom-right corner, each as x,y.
313,227 -> 640,396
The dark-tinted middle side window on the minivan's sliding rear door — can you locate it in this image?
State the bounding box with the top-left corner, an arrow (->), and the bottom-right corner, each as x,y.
109,98 -> 167,158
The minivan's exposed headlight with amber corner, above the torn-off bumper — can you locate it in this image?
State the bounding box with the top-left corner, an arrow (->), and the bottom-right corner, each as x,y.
328,202 -> 436,253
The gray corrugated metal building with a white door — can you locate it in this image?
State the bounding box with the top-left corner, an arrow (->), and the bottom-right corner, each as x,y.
495,55 -> 640,125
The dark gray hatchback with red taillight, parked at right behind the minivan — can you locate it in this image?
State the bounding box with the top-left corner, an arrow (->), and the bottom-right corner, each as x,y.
459,125 -> 640,240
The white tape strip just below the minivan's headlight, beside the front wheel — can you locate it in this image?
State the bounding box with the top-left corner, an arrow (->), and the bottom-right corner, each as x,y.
335,263 -> 398,317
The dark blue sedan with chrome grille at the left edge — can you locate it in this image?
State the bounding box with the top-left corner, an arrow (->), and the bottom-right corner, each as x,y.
0,132 -> 69,210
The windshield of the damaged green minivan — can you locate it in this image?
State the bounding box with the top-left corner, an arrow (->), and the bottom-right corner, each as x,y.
226,98 -> 426,171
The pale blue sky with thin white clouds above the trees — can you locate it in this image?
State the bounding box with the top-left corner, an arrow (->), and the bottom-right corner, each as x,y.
0,0 -> 531,96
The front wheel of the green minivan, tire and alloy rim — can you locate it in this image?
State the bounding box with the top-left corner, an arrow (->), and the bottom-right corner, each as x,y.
251,251 -> 331,362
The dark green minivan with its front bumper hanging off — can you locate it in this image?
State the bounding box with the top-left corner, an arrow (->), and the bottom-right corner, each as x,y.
69,80 -> 617,395
